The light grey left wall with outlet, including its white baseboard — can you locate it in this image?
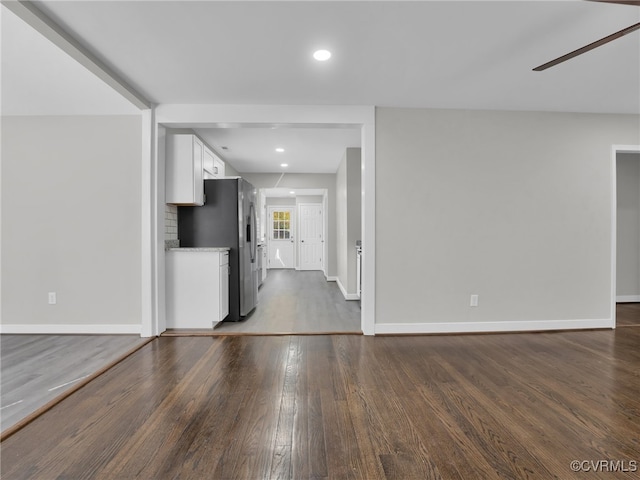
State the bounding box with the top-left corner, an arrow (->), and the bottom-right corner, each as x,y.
2,116 -> 142,333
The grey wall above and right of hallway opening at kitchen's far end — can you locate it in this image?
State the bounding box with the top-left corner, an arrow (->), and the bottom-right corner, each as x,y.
241,173 -> 337,278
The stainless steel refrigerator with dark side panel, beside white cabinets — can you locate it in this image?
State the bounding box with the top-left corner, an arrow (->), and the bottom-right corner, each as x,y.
178,178 -> 258,322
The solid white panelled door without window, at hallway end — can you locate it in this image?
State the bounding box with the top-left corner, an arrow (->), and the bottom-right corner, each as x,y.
298,203 -> 324,270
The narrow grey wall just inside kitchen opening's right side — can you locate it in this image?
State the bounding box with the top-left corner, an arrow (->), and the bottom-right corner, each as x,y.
336,148 -> 362,299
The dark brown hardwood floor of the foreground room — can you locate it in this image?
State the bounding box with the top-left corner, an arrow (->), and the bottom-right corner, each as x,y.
0,328 -> 640,480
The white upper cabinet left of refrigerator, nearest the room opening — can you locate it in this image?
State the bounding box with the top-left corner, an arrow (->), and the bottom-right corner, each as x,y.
165,133 -> 205,205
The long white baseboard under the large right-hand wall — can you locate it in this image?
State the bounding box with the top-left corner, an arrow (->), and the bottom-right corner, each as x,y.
375,318 -> 614,334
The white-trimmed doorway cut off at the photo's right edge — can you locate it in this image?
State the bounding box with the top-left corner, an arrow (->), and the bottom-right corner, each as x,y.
612,146 -> 640,326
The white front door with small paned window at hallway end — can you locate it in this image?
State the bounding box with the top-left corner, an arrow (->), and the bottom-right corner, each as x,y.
267,207 -> 295,268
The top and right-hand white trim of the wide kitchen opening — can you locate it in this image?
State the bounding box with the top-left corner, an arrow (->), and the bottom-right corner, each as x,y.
154,104 -> 376,335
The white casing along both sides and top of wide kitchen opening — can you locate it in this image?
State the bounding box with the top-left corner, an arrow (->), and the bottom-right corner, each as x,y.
152,104 -> 376,336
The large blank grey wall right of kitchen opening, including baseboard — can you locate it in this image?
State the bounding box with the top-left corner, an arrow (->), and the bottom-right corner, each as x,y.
376,108 -> 640,332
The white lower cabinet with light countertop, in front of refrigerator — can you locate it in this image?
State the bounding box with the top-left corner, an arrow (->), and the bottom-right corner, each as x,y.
165,248 -> 229,328
